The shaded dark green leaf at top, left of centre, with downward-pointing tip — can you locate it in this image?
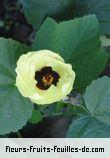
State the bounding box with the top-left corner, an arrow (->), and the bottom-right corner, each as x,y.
21,0 -> 73,29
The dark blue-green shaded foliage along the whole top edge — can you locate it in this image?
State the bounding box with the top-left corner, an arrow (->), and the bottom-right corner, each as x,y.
21,0 -> 110,34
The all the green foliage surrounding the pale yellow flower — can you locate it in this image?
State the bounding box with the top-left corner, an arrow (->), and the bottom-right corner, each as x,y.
0,0 -> 110,138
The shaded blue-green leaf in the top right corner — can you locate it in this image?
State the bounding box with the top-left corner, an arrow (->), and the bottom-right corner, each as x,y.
74,0 -> 110,34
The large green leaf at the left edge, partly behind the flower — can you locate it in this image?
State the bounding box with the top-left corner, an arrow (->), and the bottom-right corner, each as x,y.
0,38 -> 33,135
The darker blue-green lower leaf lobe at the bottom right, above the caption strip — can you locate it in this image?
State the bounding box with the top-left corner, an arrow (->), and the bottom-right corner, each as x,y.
66,115 -> 110,138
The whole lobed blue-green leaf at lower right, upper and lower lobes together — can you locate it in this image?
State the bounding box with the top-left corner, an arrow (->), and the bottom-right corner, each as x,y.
67,77 -> 110,138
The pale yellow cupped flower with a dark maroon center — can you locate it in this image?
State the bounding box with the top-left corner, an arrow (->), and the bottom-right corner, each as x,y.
16,50 -> 75,104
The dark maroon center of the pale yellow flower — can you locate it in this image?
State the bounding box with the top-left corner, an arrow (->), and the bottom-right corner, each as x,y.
35,66 -> 60,90
